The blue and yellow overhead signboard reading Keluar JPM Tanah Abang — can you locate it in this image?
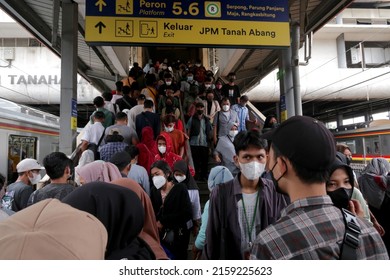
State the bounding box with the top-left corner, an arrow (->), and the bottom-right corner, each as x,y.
85,0 -> 290,48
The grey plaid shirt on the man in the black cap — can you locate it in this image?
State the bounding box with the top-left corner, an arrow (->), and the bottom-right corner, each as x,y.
251,196 -> 389,260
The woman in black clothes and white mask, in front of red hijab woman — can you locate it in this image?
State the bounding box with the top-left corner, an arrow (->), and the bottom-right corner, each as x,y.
150,160 -> 192,260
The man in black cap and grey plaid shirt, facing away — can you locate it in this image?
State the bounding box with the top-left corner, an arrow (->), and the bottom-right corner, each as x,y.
250,116 -> 389,260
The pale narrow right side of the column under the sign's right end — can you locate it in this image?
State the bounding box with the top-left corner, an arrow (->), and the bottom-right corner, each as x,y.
291,23 -> 302,116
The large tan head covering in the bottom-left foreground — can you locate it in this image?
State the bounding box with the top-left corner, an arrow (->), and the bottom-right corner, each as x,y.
0,198 -> 107,260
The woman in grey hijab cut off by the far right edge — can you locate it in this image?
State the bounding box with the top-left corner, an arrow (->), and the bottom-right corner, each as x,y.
358,158 -> 390,252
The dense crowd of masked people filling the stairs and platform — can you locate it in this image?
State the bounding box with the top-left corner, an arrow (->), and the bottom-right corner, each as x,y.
0,60 -> 390,260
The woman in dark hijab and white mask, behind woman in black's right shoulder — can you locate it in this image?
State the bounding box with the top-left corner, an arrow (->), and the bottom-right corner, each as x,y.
173,160 -> 201,236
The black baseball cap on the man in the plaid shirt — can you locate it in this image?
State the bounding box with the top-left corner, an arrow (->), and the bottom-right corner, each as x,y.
262,116 -> 336,171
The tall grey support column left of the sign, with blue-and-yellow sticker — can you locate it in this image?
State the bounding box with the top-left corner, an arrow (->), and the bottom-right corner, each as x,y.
60,1 -> 78,155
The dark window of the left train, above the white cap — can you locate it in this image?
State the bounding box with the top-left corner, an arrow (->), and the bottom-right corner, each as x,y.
8,135 -> 37,182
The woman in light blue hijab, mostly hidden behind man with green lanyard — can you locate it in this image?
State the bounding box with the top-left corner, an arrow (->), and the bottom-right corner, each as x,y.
192,166 -> 233,259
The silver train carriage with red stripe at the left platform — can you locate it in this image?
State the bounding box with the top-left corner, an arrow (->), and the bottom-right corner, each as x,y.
0,99 -> 60,182
